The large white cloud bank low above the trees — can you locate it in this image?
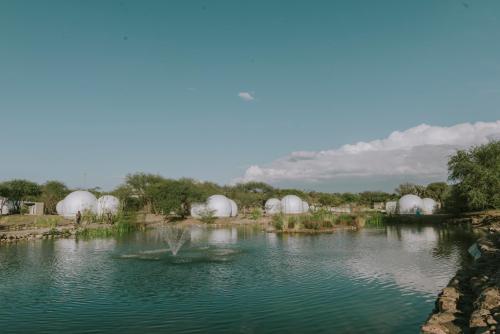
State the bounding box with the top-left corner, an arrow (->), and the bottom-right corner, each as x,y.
235,121 -> 500,188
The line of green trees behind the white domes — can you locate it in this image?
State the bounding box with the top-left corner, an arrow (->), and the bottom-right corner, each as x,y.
0,141 -> 500,217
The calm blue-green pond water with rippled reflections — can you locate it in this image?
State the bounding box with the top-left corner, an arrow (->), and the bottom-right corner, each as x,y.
0,226 -> 474,334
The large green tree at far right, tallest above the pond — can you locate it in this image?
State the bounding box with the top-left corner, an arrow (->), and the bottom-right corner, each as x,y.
448,141 -> 500,210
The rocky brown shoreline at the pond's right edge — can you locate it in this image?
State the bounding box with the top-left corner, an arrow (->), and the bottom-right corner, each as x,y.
421,214 -> 500,334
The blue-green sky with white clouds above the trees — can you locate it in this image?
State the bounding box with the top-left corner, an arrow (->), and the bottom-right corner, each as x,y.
0,0 -> 500,192
